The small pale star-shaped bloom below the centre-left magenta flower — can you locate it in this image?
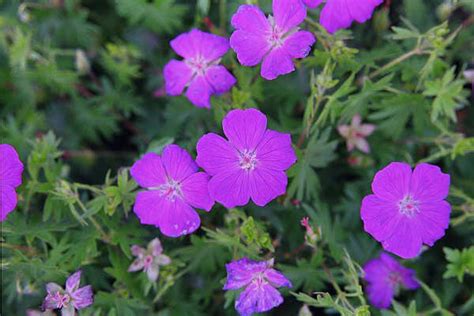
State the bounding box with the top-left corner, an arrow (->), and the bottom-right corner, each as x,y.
128,238 -> 171,282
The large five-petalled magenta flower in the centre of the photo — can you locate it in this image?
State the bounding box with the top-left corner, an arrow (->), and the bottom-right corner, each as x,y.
196,109 -> 296,208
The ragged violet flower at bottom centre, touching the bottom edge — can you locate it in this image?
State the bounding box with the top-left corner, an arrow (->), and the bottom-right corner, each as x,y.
224,258 -> 292,316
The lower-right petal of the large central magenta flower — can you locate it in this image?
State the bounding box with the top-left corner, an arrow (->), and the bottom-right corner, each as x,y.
249,167 -> 288,207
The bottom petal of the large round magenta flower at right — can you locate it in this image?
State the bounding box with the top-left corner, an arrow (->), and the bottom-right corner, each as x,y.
382,219 -> 422,259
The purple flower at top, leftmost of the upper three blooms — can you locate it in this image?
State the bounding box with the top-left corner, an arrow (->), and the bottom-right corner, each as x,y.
163,30 -> 236,108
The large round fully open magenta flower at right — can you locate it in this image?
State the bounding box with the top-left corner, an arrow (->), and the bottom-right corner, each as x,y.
361,162 -> 451,259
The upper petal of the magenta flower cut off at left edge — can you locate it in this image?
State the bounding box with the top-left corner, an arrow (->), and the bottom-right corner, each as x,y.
0,144 -> 23,188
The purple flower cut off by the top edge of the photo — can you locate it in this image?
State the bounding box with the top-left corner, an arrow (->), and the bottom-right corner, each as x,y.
303,0 -> 383,33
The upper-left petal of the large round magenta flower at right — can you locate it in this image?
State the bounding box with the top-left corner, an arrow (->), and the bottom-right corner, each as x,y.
372,162 -> 411,202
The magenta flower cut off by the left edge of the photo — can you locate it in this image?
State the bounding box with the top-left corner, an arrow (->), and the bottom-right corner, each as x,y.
0,144 -> 23,222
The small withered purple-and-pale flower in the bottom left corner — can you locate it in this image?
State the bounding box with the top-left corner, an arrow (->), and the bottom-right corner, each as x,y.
43,270 -> 94,316
